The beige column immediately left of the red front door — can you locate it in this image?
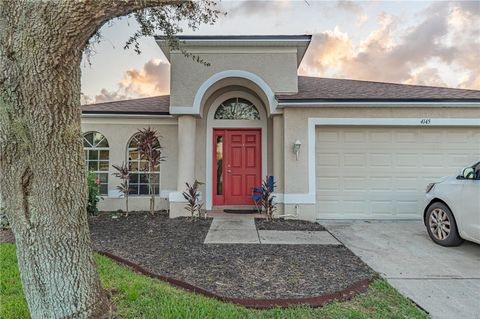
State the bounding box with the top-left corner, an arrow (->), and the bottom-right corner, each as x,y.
177,115 -> 196,192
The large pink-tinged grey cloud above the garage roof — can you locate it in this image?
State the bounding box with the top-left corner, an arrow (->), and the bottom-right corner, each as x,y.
300,3 -> 480,89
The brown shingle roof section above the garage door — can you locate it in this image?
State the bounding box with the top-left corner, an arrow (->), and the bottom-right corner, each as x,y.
277,76 -> 480,102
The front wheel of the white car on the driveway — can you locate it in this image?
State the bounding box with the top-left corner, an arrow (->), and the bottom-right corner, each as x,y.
425,203 -> 463,246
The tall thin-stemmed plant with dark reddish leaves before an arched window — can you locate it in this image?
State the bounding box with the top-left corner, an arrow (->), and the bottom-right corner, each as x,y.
137,127 -> 165,216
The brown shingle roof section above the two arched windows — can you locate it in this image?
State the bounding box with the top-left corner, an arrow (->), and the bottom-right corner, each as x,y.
82,95 -> 170,115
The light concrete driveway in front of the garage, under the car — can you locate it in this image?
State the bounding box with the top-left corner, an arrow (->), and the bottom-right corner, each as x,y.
320,221 -> 480,319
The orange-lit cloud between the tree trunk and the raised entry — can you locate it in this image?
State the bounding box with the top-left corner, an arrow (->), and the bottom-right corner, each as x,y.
81,59 -> 170,104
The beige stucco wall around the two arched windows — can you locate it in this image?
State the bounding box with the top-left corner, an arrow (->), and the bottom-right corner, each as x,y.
82,117 -> 177,211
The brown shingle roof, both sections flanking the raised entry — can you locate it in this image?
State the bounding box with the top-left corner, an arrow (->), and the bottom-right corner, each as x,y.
82,76 -> 480,115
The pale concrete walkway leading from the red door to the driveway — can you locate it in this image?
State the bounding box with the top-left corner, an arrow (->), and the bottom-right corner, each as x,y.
204,216 -> 341,245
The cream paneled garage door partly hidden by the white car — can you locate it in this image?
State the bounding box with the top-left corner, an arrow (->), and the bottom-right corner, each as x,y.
316,126 -> 480,219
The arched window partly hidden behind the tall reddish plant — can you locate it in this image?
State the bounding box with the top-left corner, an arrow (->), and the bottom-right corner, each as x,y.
128,134 -> 160,195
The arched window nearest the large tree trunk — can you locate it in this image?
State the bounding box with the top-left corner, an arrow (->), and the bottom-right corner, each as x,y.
83,132 -> 109,195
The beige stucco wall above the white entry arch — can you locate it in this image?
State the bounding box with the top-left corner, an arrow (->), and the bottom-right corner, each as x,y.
170,47 -> 298,107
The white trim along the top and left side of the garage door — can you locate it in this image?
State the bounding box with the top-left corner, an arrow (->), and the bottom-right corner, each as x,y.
283,117 -> 480,204
